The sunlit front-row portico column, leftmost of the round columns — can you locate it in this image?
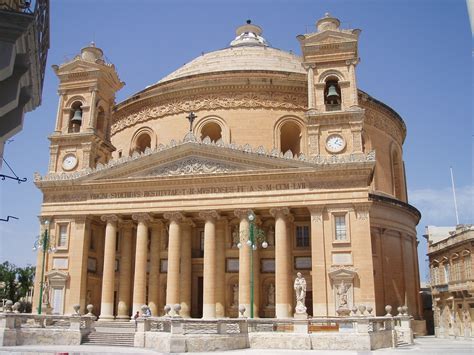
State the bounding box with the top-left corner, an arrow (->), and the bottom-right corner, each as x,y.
99,215 -> 118,320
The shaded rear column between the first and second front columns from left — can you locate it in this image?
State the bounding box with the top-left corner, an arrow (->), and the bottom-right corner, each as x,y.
117,221 -> 133,320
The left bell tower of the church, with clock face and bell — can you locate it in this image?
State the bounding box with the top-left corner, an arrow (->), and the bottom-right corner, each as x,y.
48,43 -> 124,173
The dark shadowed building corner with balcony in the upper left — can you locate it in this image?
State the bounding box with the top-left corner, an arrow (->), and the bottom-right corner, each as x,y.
0,0 -> 49,167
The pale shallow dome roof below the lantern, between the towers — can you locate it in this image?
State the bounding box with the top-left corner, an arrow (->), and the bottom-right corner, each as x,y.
159,46 -> 306,83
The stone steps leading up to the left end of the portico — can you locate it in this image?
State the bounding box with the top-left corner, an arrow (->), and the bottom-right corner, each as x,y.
82,322 -> 135,346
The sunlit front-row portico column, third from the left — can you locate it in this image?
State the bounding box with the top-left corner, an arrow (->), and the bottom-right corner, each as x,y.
164,212 -> 184,314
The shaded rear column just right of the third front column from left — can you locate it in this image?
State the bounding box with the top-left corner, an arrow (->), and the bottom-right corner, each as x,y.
180,218 -> 195,318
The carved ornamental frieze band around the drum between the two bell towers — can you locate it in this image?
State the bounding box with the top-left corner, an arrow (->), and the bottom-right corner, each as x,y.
111,92 -> 306,135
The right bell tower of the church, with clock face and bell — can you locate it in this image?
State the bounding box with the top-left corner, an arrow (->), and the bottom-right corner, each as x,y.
297,13 -> 364,156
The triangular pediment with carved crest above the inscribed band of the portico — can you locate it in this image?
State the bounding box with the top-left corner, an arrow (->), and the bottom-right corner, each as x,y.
35,138 -> 375,186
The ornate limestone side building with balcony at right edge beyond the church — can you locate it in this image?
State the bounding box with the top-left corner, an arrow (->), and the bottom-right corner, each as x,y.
424,224 -> 474,338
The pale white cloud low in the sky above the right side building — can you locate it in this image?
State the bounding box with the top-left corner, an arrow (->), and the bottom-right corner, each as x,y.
408,186 -> 474,226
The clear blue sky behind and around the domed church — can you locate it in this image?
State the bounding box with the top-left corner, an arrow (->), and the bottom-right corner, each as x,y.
0,0 -> 474,279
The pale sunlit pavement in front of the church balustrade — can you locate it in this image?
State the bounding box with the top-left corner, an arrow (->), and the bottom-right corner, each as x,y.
0,336 -> 474,355
